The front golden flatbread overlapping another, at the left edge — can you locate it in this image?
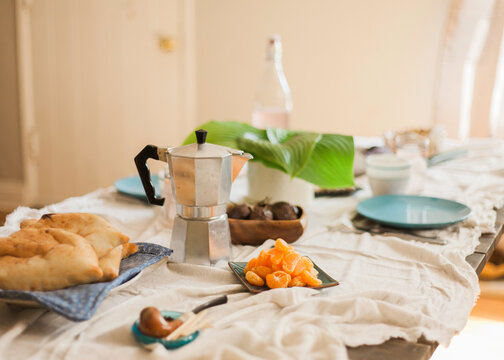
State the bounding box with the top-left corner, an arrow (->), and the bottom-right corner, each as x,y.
0,229 -> 103,291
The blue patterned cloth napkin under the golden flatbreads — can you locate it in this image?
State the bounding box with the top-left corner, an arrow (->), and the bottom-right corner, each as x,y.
0,243 -> 173,321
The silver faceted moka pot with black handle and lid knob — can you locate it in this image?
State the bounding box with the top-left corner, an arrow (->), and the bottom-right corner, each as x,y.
135,130 -> 252,265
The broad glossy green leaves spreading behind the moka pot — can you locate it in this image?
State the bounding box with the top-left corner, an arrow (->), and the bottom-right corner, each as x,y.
184,121 -> 354,188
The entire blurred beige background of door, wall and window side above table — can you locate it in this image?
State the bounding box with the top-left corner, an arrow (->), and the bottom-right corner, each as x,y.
0,0 -> 504,205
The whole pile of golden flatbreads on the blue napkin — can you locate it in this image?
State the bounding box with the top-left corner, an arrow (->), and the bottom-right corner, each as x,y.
0,213 -> 138,291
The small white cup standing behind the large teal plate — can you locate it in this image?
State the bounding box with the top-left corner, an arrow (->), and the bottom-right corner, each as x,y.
366,154 -> 412,195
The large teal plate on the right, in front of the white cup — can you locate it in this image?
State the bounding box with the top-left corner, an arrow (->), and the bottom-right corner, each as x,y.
357,195 -> 471,229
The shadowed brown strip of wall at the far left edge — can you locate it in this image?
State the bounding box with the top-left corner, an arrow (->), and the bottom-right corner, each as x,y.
0,0 -> 23,182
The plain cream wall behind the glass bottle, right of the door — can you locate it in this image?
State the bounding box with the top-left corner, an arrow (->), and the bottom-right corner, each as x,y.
196,0 -> 449,135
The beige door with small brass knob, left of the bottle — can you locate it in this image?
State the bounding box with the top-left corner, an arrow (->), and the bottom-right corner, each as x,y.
30,0 -> 185,204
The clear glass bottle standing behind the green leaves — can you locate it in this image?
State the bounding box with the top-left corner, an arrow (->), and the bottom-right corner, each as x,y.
252,35 -> 292,129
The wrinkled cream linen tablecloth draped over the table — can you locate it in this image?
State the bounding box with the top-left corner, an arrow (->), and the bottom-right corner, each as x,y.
0,140 -> 504,360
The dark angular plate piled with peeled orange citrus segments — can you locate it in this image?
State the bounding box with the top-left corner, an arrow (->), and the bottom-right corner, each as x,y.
228,239 -> 339,293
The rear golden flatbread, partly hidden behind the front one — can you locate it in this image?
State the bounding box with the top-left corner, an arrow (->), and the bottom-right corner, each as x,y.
20,213 -> 129,281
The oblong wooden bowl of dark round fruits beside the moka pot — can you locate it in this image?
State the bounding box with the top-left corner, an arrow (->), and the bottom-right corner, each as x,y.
228,202 -> 308,246
